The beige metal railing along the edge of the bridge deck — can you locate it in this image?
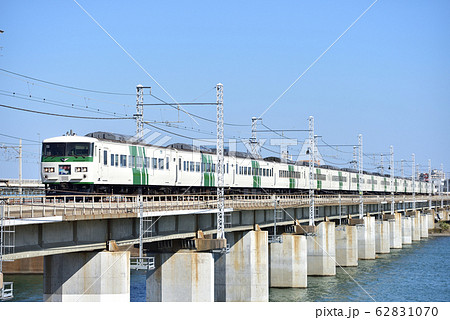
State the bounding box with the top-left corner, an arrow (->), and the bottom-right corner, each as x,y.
1,194 -> 450,219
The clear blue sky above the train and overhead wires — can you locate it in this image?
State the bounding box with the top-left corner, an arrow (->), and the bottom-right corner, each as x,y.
0,0 -> 450,178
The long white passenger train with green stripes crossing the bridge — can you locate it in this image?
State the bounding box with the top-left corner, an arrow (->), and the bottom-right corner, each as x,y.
41,132 -> 428,194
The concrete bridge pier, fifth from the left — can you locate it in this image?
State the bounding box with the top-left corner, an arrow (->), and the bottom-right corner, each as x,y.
307,221 -> 336,276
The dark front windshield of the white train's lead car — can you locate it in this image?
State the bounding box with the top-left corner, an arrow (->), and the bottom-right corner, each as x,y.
42,142 -> 94,157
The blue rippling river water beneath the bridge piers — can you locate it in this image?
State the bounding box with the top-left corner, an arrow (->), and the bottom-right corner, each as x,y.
5,237 -> 450,302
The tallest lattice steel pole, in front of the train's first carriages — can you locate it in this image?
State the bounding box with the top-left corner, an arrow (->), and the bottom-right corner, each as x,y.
216,83 -> 225,239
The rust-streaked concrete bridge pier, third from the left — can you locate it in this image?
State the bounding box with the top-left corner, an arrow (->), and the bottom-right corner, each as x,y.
214,230 -> 269,302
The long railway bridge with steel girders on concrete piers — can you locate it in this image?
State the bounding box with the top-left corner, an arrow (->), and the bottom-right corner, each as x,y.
0,194 -> 450,301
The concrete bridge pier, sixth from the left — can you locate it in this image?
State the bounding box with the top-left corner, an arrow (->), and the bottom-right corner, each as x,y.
335,225 -> 358,267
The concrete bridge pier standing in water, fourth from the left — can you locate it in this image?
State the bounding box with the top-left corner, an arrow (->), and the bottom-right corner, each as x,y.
269,234 -> 308,288
